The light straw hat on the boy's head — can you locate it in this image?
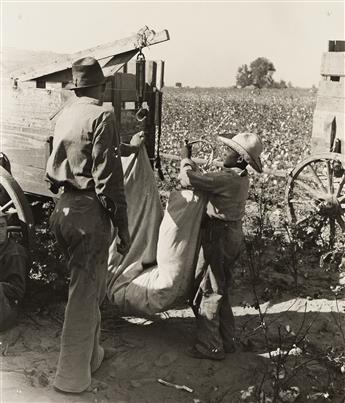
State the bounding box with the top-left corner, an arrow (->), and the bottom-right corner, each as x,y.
218,132 -> 263,173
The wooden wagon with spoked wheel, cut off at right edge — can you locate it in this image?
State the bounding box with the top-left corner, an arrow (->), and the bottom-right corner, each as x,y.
286,41 -> 345,246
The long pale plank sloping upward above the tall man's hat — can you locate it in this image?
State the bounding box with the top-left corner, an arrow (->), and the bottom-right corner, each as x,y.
11,30 -> 170,81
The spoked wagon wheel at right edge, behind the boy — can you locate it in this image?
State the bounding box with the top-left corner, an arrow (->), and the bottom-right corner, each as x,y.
285,153 -> 345,248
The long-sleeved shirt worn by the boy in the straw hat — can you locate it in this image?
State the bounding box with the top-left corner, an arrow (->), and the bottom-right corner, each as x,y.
180,158 -> 249,221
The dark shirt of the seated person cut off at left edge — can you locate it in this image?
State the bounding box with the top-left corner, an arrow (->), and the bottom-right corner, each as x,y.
0,239 -> 28,301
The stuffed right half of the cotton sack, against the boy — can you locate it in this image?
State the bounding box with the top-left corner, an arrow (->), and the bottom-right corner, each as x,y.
113,190 -> 205,316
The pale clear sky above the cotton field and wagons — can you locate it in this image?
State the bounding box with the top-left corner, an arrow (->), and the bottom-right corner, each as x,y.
1,0 -> 345,87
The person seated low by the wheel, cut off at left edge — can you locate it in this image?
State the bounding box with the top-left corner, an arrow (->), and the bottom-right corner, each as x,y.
0,211 -> 29,332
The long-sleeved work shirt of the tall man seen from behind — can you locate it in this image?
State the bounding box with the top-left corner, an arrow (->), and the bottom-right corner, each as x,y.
46,97 -> 127,226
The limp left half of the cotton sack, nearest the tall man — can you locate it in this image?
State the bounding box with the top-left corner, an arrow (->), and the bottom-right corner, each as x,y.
108,144 -> 163,301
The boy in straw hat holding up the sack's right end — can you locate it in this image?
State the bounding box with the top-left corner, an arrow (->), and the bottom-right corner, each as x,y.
180,133 -> 262,360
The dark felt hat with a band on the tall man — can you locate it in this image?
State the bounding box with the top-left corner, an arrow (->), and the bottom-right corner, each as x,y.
66,57 -> 105,90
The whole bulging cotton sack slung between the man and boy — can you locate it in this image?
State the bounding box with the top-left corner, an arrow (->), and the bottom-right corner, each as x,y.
108,144 -> 206,316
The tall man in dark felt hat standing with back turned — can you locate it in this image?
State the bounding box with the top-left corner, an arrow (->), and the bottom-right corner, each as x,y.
46,57 -> 130,393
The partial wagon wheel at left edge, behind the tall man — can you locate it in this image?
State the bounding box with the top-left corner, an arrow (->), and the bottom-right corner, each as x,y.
0,166 -> 34,248
